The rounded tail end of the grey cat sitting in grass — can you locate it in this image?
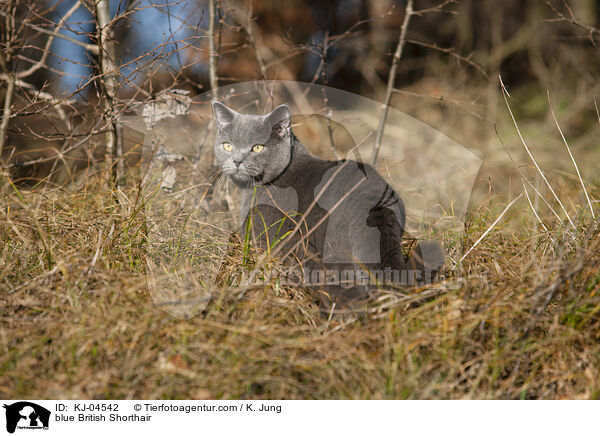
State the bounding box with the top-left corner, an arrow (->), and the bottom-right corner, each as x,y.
406,241 -> 445,286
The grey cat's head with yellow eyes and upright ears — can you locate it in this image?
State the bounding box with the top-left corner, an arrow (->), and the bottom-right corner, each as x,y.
212,101 -> 291,188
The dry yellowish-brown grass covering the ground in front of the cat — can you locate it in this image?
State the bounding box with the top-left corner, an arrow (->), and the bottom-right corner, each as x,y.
0,147 -> 600,399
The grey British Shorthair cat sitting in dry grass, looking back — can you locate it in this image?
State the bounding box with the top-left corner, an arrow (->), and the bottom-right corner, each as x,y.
212,101 -> 444,302
